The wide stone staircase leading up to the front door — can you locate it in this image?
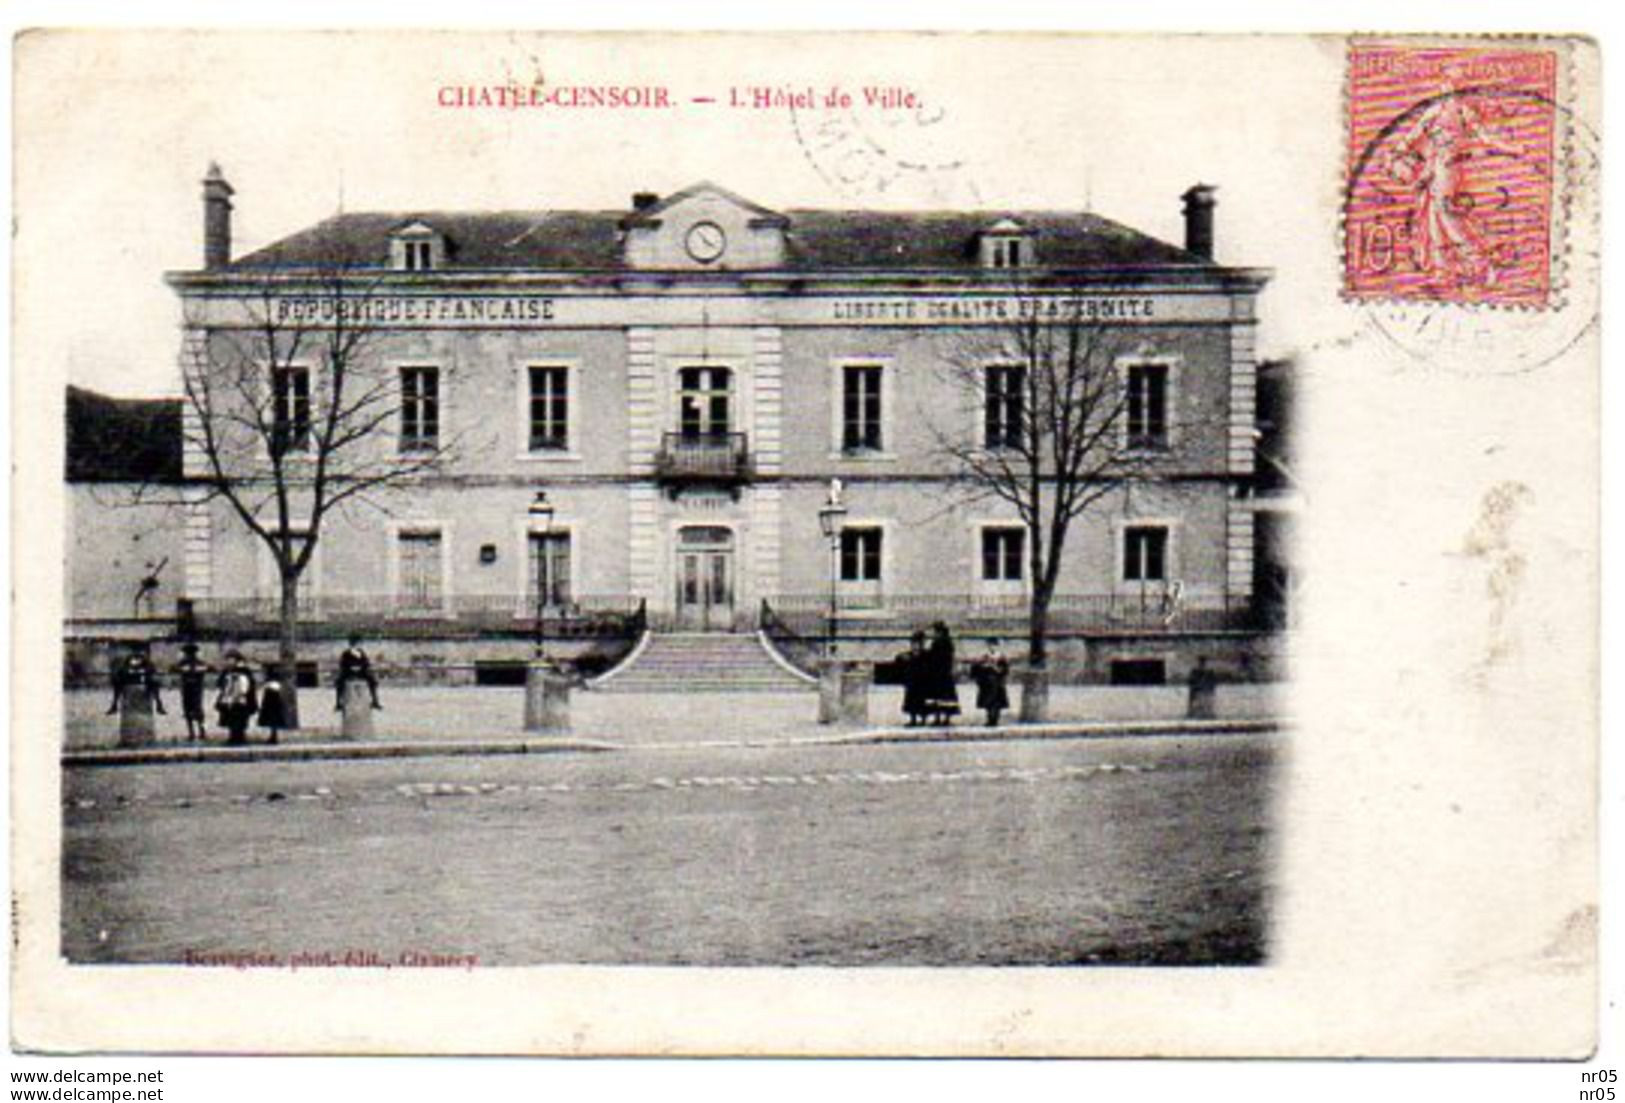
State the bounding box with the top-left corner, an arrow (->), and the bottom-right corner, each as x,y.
593,632 -> 816,694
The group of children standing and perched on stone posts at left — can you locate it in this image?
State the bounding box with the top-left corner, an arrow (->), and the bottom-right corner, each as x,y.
107,637 -> 384,746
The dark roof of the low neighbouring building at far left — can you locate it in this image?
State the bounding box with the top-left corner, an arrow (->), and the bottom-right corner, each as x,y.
67,387 -> 182,482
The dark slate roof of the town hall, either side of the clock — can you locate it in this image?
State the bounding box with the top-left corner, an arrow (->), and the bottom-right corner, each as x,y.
229,210 -> 1214,271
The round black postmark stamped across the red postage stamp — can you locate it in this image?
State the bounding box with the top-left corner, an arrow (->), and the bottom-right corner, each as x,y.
1342,84 -> 1601,375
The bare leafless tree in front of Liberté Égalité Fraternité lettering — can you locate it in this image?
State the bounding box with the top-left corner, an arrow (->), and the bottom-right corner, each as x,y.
931,289 -> 1172,669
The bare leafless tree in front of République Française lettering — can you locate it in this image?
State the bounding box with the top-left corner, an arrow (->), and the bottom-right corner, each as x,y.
180,237 -> 457,726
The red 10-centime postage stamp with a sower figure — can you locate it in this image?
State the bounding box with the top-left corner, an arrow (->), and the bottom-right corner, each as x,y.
1342,44 -> 1558,307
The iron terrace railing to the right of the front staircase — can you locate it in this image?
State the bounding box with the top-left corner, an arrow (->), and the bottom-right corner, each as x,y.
762,586 -> 1263,638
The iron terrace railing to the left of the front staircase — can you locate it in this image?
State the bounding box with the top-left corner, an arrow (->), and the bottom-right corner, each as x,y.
192,593 -> 647,638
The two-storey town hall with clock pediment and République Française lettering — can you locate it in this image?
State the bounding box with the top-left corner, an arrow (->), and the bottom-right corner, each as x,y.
69,167 -> 1268,681
